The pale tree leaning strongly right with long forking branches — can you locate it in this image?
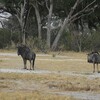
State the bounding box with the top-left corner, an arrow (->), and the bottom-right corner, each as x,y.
52,0 -> 97,50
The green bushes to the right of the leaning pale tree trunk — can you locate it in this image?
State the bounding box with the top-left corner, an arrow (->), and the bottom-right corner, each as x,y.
58,31 -> 100,51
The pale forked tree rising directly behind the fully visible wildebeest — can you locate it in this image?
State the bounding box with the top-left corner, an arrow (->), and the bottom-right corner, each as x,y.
3,0 -> 29,44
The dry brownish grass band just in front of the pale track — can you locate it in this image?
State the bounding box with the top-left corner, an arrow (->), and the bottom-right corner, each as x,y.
0,73 -> 100,92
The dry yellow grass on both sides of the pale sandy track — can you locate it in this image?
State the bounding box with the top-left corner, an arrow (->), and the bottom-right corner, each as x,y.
0,51 -> 100,100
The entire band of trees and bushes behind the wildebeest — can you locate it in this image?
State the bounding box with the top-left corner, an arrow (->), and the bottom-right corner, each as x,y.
0,0 -> 100,52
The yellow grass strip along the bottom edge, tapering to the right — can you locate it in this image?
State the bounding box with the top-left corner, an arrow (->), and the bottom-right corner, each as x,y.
0,91 -> 74,100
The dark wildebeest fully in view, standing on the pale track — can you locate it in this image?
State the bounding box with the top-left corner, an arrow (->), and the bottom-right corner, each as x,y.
17,45 -> 36,70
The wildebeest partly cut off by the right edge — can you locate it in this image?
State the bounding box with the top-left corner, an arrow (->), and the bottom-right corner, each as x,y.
87,52 -> 100,73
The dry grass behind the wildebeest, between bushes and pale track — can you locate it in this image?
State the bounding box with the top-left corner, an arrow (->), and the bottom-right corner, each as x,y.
0,52 -> 92,72
